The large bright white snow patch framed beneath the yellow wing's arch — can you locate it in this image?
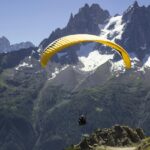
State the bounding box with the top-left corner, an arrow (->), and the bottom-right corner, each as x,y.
79,50 -> 114,72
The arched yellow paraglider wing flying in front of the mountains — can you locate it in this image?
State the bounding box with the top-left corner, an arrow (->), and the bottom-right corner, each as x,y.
40,34 -> 131,69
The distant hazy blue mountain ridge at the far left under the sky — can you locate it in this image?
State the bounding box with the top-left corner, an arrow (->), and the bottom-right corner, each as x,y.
0,36 -> 35,53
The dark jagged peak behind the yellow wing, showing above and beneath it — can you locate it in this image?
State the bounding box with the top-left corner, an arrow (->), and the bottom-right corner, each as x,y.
39,4 -> 110,63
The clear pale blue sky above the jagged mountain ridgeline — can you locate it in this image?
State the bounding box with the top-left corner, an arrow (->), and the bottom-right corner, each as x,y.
0,0 -> 150,45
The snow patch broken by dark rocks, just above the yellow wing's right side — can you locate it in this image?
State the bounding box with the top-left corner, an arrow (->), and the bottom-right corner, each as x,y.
100,16 -> 125,41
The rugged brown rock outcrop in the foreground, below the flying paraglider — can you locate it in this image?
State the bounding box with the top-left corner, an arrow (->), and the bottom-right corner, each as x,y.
75,125 -> 145,150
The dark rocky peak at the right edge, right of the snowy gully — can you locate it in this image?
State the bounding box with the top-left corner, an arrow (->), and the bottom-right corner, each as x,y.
121,2 -> 150,59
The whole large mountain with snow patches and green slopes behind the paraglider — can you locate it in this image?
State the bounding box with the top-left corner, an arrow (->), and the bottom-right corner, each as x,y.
0,2 -> 150,150
